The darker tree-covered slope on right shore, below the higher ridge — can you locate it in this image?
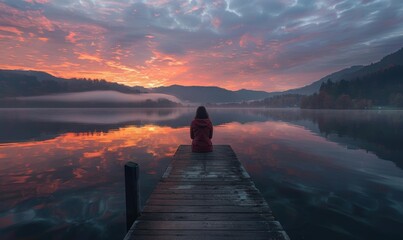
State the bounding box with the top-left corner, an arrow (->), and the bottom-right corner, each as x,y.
301,65 -> 403,109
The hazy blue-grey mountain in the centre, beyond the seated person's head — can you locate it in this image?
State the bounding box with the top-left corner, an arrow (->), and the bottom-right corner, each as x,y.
152,85 -> 271,103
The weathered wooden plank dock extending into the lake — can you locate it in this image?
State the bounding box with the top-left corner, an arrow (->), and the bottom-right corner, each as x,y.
124,145 -> 289,240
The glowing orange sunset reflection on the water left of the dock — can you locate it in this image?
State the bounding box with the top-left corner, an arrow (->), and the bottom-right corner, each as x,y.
0,125 -> 187,239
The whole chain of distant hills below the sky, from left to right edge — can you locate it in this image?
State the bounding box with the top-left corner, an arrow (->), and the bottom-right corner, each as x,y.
0,48 -> 403,104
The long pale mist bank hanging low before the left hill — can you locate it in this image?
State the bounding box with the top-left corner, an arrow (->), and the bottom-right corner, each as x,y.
17,91 -> 181,103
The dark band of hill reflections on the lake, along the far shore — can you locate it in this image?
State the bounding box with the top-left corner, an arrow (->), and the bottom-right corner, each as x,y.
0,108 -> 403,171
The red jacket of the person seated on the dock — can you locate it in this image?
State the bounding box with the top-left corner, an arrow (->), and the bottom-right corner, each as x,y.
190,119 -> 213,152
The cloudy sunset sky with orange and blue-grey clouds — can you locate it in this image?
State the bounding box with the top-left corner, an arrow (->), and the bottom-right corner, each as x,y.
0,0 -> 403,91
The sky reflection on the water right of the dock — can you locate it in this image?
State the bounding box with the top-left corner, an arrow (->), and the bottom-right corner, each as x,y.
226,122 -> 403,239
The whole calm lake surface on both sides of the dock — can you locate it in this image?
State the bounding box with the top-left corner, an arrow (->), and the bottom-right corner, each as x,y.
0,109 -> 403,240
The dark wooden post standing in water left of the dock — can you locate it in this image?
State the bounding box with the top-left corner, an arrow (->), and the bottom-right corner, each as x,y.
125,162 -> 141,231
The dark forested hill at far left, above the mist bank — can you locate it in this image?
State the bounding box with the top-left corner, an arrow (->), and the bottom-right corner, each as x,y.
0,70 -> 140,98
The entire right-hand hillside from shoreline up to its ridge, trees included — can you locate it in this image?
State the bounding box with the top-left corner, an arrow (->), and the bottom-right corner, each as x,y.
301,48 -> 403,109
